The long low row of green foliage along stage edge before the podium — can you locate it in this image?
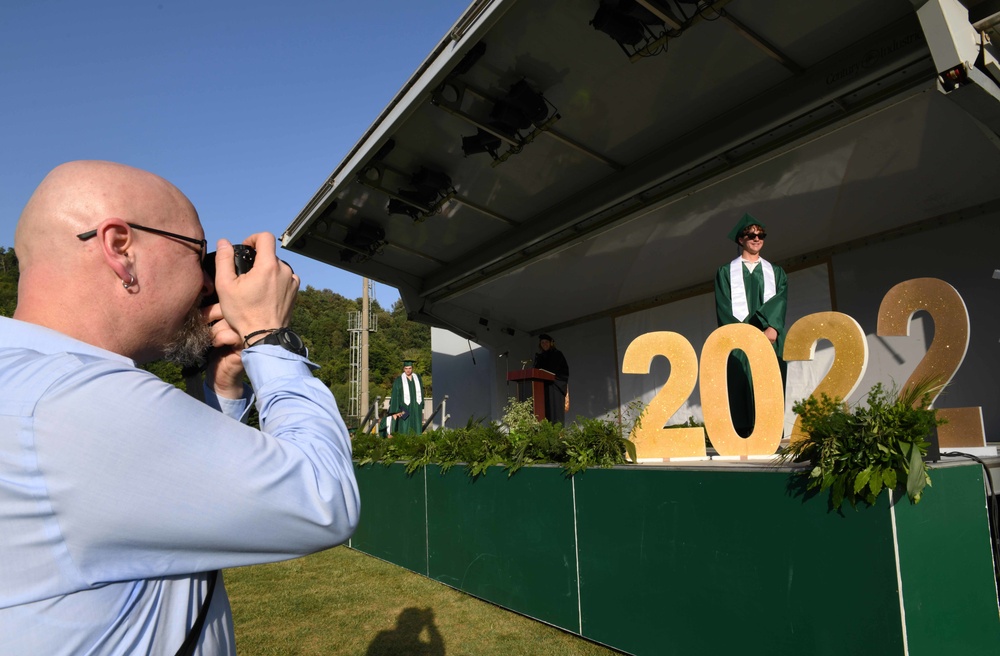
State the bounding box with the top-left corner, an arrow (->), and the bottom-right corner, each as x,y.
353,400 -> 635,478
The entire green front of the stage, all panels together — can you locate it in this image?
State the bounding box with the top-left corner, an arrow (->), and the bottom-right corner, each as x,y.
350,458 -> 1000,656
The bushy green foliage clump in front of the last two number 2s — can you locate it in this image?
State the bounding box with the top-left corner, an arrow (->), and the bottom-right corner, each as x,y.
779,380 -> 944,509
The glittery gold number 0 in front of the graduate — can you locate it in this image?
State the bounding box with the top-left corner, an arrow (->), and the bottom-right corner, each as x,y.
701,323 -> 785,456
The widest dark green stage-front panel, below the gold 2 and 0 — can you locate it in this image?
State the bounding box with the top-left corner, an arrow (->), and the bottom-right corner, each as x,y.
576,468 -> 908,656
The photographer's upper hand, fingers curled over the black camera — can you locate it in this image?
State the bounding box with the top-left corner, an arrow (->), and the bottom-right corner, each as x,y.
215,232 -> 299,344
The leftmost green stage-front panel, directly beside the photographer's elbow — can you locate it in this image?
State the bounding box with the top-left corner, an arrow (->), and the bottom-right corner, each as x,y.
351,464 -> 427,576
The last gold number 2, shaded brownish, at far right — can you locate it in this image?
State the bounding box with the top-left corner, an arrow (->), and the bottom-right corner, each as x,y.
876,278 -> 986,447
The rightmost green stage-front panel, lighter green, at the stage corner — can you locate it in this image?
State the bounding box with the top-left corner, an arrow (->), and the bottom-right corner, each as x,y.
896,464 -> 1000,656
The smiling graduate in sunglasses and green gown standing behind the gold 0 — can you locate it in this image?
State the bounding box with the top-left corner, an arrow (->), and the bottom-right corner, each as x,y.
715,214 -> 788,437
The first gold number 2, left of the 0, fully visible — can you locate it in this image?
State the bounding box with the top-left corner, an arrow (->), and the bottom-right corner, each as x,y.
622,331 -> 705,459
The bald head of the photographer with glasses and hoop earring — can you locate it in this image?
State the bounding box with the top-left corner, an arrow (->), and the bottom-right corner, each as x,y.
14,161 -> 211,359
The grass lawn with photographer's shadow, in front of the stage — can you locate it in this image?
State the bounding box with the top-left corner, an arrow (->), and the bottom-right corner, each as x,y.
225,547 -> 619,656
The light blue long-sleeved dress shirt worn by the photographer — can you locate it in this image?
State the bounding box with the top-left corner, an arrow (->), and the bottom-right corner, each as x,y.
0,317 -> 360,656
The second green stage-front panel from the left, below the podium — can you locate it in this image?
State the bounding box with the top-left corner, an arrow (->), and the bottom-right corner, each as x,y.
427,466 -> 579,631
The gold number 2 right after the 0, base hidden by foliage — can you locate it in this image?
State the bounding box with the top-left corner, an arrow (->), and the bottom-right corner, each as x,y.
784,312 -> 868,442
